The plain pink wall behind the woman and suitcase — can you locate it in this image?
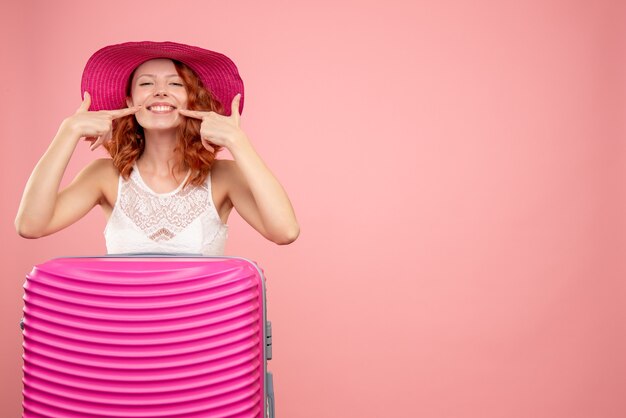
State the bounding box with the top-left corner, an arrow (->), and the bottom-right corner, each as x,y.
0,0 -> 626,418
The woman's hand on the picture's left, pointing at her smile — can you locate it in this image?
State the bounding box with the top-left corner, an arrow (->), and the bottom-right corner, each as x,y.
63,92 -> 142,151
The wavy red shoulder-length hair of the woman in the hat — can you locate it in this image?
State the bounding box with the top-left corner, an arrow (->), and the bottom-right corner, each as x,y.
103,60 -> 224,187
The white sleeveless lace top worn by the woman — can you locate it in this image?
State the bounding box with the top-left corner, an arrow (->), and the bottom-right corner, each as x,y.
104,164 -> 228,255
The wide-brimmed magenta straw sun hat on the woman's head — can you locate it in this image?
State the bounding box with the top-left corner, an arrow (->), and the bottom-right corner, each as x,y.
81,41 -> 243,116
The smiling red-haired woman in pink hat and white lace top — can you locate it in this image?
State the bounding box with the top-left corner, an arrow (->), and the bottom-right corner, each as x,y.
15,42 -> 299,255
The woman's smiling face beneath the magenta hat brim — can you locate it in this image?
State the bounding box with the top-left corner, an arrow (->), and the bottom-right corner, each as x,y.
126,58 -> 187,129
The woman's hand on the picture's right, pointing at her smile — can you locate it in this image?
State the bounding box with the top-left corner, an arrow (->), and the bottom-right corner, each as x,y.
178,93 -> 246,151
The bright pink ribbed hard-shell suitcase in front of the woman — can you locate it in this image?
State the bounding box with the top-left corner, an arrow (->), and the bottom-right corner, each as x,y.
23,255 -> 274,418
